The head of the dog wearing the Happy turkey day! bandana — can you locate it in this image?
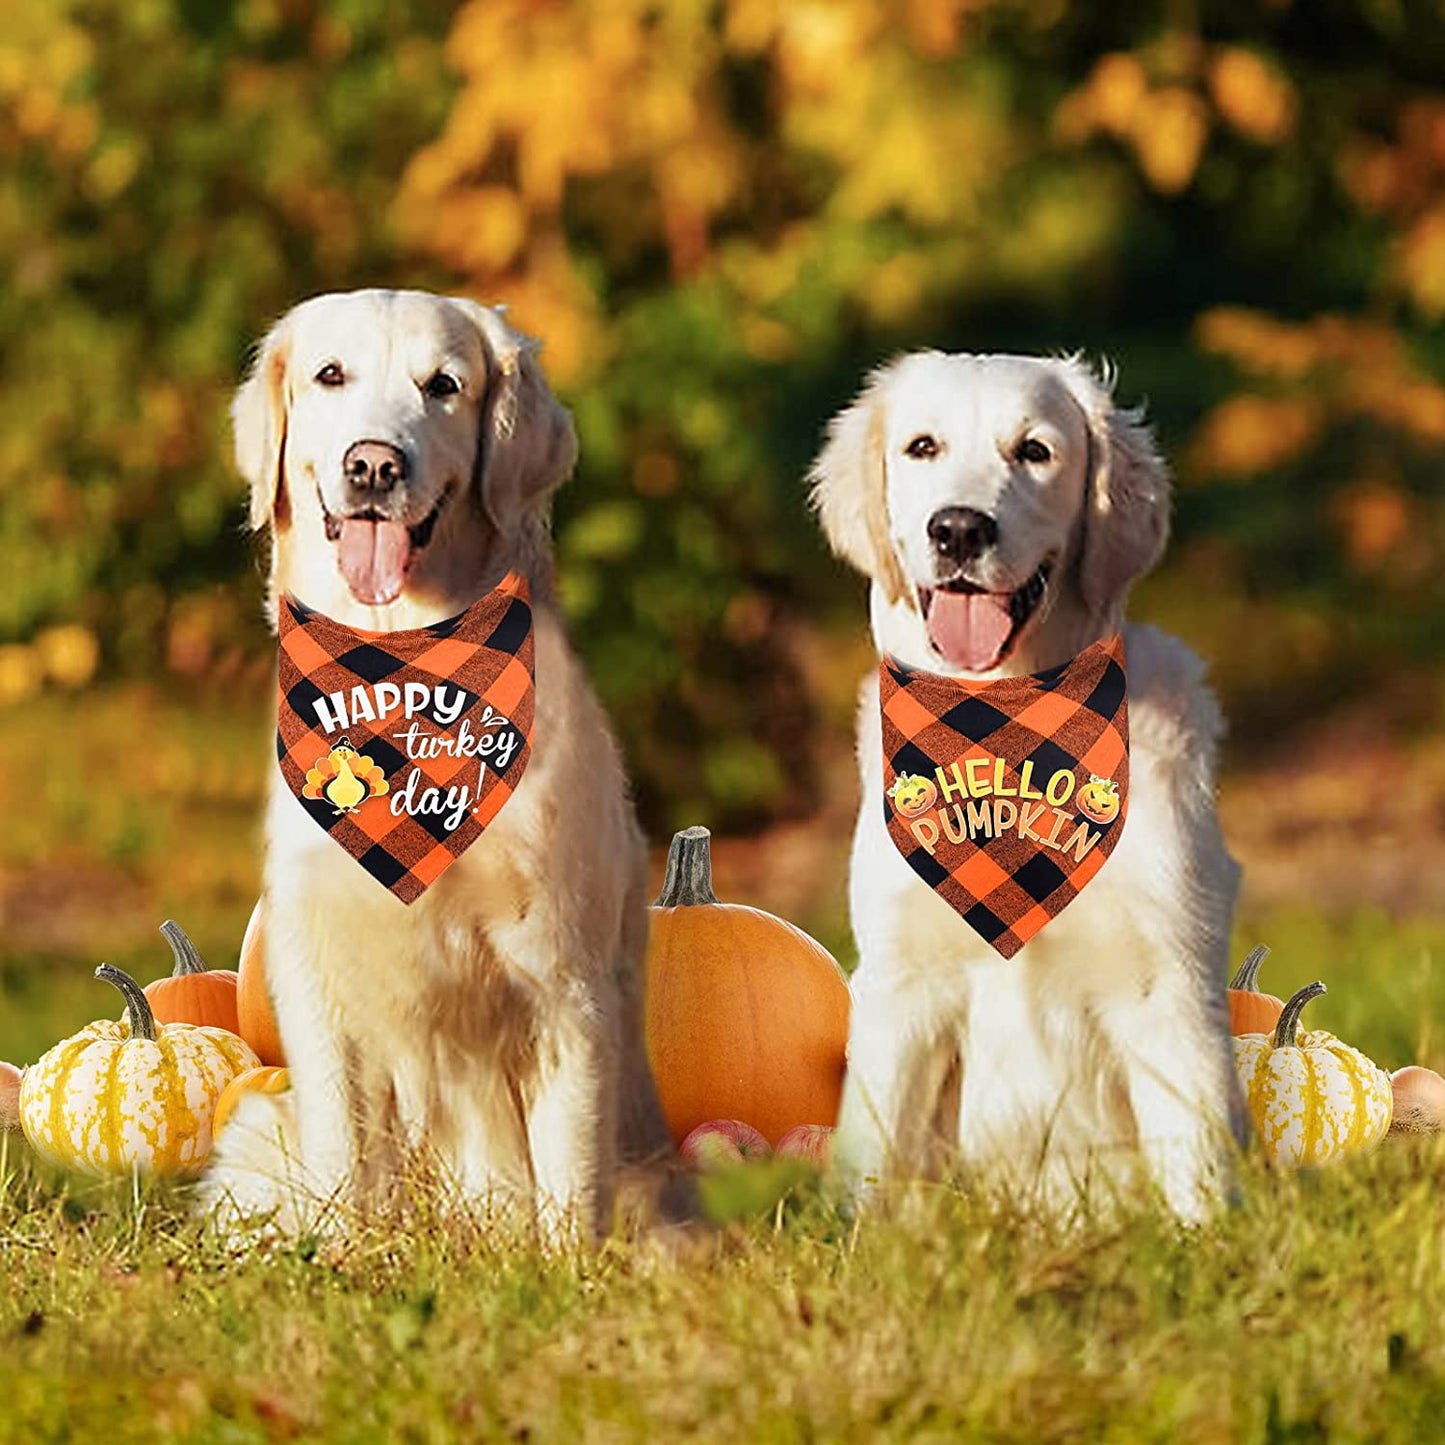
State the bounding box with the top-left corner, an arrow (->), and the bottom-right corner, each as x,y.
233,290 -> 577,623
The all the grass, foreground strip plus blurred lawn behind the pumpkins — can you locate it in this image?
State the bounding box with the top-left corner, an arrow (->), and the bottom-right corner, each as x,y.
0,696 -> 1445,1445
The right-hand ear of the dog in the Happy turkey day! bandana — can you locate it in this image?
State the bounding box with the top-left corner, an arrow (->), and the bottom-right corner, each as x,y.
454,296 -> 577,535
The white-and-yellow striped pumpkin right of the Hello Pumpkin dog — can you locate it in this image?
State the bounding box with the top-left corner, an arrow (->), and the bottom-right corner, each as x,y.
1234,983 -> 1394,1169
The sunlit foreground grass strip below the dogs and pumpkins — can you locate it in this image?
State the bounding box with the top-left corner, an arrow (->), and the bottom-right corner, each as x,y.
0,1146 -> 1445,1445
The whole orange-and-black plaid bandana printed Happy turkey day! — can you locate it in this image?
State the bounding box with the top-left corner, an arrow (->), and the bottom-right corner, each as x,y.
276,572 -> 536,903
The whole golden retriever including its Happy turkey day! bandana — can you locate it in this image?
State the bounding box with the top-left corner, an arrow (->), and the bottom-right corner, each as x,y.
202,290 -> 666,1244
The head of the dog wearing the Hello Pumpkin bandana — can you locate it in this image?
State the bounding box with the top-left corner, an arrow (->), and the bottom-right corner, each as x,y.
812,351 -> 1169,673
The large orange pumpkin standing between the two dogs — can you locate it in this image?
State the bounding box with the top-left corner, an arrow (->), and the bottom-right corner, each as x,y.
646,828 -> 850,1144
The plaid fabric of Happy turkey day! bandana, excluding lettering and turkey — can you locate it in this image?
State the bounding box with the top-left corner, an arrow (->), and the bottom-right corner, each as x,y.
276,572 -> 536,903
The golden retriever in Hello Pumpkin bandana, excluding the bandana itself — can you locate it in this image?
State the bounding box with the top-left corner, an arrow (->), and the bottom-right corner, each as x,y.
812,351 -> 1243,1220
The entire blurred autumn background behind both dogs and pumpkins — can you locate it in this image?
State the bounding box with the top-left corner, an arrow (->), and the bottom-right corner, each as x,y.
0,0 -> 1445,1056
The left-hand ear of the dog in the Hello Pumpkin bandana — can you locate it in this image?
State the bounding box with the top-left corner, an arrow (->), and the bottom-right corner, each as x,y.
808,367 -> 907,603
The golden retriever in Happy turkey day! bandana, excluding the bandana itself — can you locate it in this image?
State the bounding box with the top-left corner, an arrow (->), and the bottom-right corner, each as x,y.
204,290 -> 665,1240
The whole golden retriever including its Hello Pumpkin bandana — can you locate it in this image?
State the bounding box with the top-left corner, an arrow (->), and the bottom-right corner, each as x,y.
812,351 -> 1243,1220
